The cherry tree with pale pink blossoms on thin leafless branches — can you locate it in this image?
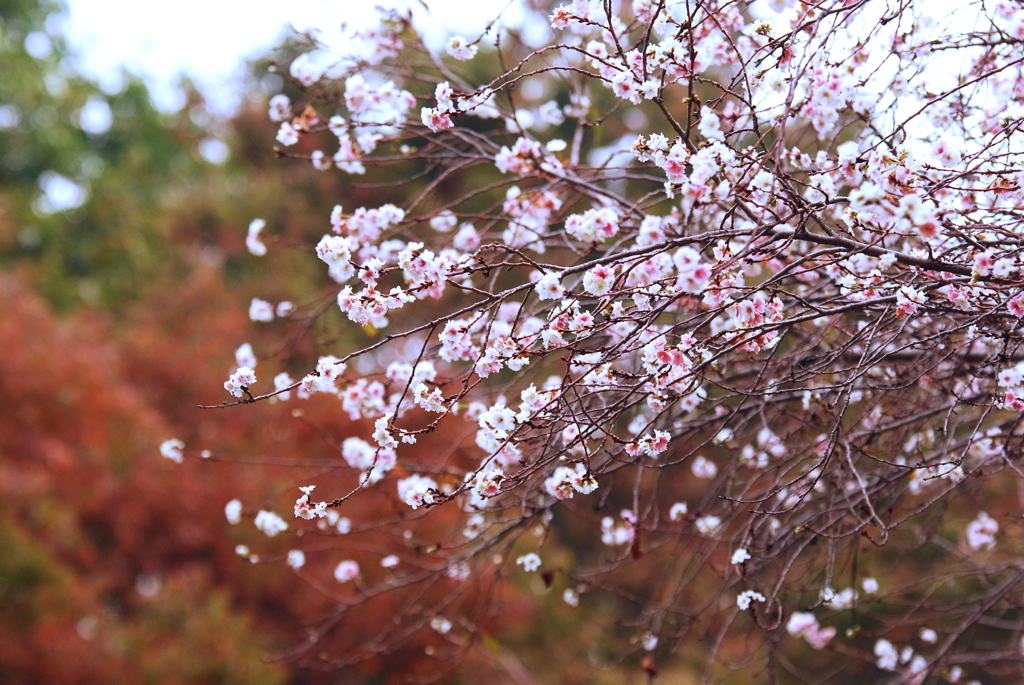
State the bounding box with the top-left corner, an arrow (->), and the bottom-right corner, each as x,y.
165,0 -> 1024,683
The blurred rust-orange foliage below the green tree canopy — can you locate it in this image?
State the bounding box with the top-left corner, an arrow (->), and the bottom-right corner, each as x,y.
0,261 -> 552,683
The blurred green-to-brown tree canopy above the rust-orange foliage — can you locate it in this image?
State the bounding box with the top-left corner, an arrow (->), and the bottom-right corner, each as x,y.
0,0 -> 328,310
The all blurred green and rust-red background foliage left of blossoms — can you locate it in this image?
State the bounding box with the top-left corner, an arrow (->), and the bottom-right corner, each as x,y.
0,0 -> 598,684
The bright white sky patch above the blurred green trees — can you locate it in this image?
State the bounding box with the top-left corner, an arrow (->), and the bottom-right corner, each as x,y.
59,0 -> 519,114
